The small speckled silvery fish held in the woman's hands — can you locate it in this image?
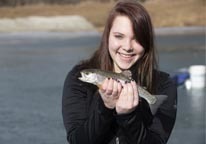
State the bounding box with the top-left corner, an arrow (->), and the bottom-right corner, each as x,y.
78,69 -> 167,114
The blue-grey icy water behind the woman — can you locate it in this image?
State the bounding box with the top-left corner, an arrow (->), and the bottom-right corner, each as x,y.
0,32 -> 205,144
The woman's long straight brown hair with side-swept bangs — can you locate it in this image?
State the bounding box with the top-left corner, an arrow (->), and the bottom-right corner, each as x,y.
80,0 -> 157,93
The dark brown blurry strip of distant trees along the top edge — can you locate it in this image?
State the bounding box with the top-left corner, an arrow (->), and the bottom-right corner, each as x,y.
0,0 -> 146,7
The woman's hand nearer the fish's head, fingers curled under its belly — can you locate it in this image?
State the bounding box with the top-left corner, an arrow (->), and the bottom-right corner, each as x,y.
99,78 -> 122,109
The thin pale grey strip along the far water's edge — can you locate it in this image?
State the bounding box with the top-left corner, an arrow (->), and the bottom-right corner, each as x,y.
0,26 -> 203,37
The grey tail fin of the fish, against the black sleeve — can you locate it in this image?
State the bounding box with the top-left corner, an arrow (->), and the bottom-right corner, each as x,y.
149,95 -> 168,115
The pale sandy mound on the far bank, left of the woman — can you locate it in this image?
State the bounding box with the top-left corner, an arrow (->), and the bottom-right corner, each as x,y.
0,15 -> 95,32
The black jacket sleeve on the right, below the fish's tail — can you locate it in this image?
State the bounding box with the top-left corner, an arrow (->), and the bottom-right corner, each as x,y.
116,73 -> 177,144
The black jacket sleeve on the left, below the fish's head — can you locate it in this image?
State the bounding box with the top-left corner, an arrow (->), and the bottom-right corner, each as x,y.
62,67 -> 114,144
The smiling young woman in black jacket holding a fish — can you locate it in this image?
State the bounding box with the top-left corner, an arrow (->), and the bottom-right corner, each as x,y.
62,0 -> 177,144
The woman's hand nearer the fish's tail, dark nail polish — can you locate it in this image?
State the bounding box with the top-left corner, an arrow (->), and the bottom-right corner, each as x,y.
116,81 -> 139,114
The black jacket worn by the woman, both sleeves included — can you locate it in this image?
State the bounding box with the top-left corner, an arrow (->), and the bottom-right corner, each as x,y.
62,66 -> 177,144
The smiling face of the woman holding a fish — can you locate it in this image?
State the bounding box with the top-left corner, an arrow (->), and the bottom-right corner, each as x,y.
109,16 -> 144,72
